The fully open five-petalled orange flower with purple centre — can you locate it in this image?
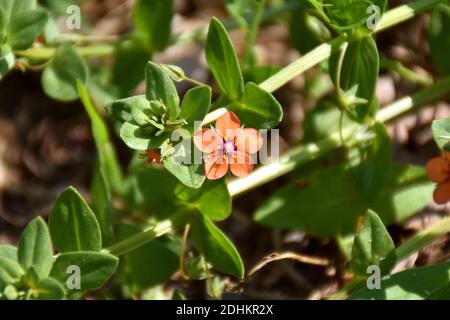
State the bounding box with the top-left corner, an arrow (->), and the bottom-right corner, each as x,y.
194,112 -> 263,180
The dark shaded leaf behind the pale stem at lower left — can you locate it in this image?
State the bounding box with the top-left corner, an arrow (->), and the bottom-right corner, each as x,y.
118,224 -> 179,289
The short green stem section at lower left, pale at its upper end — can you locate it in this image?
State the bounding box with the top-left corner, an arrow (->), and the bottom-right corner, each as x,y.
105,220 -> 173,256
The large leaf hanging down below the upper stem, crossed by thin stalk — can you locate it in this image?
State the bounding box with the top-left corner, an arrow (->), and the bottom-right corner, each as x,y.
329,33 -> 379,122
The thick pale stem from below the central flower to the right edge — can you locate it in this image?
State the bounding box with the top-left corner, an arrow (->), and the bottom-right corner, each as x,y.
228,77 -> 450,197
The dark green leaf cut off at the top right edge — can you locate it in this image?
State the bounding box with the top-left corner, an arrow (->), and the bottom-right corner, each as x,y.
428,3 -> 450,75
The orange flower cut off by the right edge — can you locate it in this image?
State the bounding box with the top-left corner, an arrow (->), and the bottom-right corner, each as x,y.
426,152 -> 450,204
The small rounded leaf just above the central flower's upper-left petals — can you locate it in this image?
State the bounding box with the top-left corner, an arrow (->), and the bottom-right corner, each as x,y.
181,86 -> 212,133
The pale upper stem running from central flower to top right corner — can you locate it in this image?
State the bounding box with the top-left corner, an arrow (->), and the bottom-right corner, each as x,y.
204,0 -> 443,125
